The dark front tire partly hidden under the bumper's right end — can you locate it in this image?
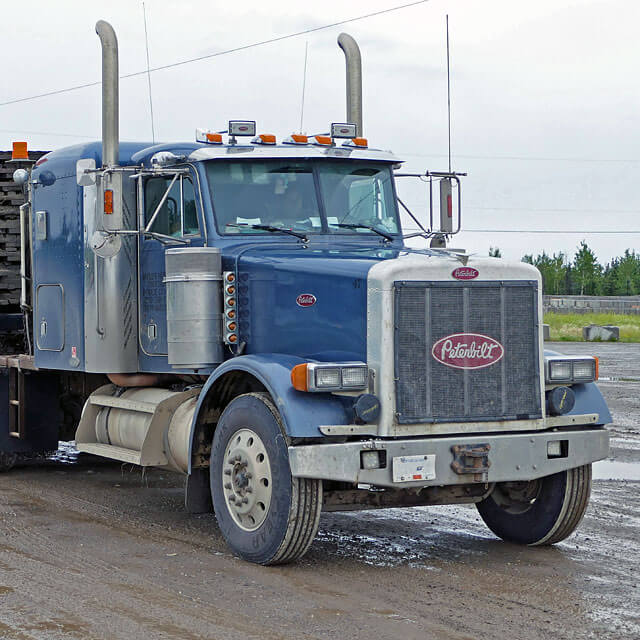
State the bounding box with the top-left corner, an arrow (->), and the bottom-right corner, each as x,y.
477,464 -> 591,546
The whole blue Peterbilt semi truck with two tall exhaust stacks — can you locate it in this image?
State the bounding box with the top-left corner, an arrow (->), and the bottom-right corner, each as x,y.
0,21 -> 611,565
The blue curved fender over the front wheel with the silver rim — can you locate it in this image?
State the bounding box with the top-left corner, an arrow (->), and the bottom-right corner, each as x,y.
189,353 -> 353,473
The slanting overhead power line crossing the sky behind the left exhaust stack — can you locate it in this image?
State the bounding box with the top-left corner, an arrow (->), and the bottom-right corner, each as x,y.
0,0 -> 430,107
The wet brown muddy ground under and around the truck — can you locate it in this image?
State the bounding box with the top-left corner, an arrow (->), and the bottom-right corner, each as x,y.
0,344 -> 640,640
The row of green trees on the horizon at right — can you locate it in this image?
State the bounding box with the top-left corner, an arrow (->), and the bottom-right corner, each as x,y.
489,241 -> 640,296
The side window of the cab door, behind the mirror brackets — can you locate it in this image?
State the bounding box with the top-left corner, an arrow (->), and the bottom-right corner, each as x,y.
144,177 -> 200,237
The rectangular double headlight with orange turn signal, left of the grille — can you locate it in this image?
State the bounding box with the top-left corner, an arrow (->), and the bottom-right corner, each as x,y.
291,362 -> 369,391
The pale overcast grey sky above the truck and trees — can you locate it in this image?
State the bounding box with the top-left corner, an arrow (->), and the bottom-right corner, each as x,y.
0,0 -> 640,262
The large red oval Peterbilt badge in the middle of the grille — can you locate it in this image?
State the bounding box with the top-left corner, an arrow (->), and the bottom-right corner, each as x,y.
431,333 -> 504,369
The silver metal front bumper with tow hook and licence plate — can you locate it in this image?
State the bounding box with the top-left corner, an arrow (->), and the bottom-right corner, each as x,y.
289,427 -> 609,488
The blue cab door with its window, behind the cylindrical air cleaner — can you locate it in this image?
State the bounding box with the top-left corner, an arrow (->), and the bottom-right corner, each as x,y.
138,172 -> 204,357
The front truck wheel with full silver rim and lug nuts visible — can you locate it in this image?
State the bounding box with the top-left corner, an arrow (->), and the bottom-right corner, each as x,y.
210,393 -> 322,565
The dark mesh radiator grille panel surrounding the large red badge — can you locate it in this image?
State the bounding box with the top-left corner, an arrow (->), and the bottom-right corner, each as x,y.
394,281 -> 542,423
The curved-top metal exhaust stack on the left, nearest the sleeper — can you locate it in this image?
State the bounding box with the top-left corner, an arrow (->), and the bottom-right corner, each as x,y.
96,20 -> 120,167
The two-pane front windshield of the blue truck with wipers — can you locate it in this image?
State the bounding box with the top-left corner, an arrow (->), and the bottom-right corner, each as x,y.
205,159 -> 398,235
